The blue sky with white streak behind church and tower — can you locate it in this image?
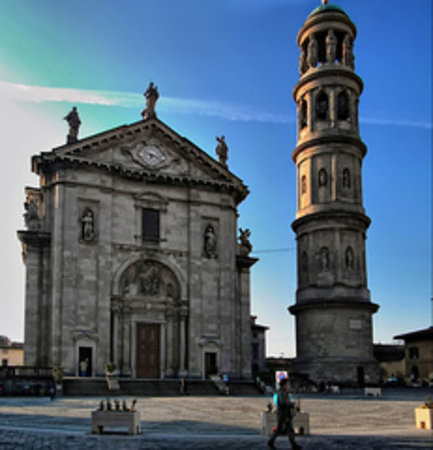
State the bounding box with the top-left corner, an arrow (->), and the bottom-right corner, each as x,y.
0,0 -> 432,355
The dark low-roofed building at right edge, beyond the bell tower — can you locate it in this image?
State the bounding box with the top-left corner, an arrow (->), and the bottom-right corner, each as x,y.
394,326 -> 433,382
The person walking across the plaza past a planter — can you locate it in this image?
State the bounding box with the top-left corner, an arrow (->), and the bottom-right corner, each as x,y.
268,378 -> 302,450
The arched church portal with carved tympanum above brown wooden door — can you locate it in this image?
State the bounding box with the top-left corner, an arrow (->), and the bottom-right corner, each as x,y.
111,259 -> 188,378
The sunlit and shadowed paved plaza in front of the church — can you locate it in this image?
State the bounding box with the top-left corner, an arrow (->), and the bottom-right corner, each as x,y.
0,389 -> 433,450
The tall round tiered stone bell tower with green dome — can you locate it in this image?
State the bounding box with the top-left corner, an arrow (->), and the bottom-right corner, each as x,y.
289,2 -> 379,385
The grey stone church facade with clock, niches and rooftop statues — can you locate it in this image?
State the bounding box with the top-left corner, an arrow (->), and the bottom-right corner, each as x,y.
18,98 -> 257,379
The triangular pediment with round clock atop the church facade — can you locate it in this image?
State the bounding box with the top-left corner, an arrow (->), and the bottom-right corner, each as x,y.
33,118 -> 248,200
